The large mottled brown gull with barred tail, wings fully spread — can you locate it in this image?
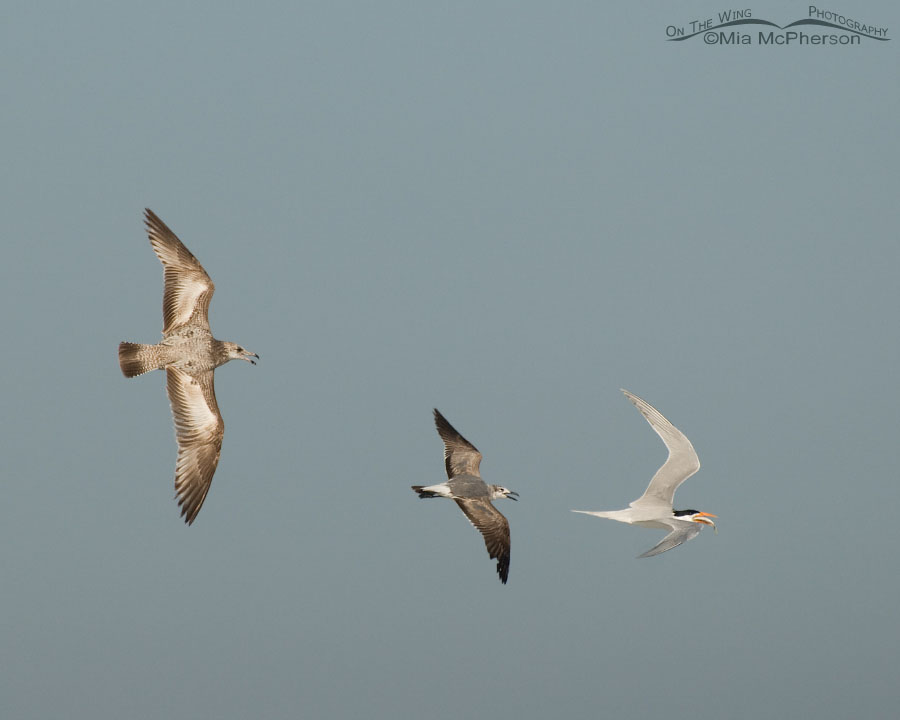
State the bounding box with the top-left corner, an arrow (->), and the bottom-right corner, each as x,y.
119,208 -> 259,525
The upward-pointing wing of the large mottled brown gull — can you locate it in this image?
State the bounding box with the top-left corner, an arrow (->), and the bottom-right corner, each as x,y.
144,208 -> 216,335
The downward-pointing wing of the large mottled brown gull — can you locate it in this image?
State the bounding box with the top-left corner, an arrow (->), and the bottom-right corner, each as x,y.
166,368 -> 225,525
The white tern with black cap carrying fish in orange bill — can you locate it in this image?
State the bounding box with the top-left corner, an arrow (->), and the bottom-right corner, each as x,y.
572,390 -> 718,557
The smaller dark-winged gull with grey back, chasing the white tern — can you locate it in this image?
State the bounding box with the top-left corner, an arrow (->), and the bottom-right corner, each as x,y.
412,408 -> 519,585
